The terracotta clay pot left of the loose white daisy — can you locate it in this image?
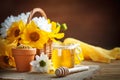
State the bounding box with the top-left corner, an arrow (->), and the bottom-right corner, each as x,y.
12,48 -> 36,72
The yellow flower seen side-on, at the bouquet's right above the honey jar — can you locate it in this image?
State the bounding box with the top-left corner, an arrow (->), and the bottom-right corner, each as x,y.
49,22 -> 64,40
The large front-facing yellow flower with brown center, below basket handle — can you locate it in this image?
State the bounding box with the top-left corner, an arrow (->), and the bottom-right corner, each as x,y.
21,21 -> 49,49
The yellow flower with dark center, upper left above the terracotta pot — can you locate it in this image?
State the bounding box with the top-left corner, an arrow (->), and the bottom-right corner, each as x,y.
7,20 -> 25,43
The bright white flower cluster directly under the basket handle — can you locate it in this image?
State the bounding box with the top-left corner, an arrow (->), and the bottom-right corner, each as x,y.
32,17 -> 51,32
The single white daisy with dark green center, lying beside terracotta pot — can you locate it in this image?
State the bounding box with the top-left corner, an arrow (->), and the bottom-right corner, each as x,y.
30,53 -> 51,73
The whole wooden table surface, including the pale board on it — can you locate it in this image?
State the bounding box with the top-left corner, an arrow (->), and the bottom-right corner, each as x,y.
0,60 -> 120,80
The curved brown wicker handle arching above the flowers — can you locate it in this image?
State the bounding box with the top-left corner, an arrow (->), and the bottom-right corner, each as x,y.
27,8 -> 47,23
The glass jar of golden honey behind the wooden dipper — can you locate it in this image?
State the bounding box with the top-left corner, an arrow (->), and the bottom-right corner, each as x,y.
52,45 -> 79,69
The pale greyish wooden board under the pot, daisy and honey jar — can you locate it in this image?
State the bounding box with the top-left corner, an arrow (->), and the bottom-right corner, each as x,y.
0,65 -> 99,80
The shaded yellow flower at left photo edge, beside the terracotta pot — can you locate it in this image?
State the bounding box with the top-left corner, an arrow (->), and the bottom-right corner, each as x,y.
0,38 -> 17,68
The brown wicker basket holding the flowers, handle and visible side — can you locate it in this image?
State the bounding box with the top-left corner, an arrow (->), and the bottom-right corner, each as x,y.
27,8 -> 52,58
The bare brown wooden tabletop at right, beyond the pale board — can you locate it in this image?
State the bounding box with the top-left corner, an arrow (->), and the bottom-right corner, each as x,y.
82,60 -> 120,80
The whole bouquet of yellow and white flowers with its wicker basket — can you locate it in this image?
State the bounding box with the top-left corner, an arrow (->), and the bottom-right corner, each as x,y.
0,8 -> 67,71
